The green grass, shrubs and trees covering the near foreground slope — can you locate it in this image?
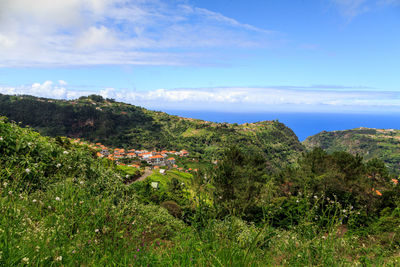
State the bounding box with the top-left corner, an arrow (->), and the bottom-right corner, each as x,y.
0,118 -> 400,266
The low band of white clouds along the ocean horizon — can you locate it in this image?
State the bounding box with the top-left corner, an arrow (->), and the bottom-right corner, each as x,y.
0,81 -> 400,112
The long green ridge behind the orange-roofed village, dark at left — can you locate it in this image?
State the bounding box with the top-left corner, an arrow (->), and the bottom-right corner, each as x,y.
0,94 -> 304,170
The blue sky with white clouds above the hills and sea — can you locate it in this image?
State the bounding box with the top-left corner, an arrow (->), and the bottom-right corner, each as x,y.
0,0 -> 400,113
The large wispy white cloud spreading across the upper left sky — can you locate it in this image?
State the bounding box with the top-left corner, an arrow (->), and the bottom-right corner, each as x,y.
0,0 -> 276,67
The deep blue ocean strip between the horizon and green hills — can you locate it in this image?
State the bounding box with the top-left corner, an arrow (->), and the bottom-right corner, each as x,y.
164,110 -> 400,141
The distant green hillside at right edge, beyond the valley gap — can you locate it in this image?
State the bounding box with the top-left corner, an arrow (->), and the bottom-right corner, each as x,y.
303,128 -> 400,174
